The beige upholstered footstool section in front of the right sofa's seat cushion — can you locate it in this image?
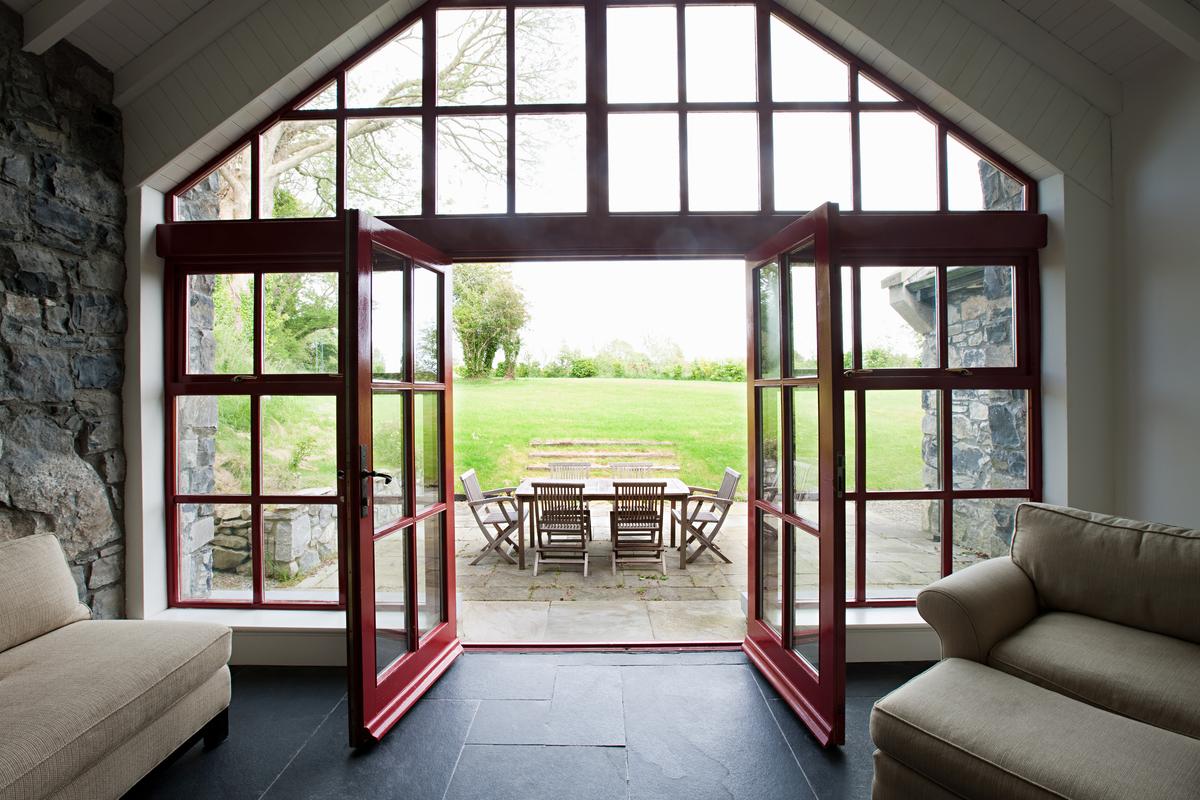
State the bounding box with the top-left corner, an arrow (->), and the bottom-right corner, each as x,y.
871,658 -> 1200,800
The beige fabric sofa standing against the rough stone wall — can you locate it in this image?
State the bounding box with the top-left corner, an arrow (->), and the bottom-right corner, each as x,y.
0,535 -> 230,800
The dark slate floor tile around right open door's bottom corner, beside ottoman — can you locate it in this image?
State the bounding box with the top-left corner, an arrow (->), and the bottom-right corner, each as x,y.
770,697 -> 875,800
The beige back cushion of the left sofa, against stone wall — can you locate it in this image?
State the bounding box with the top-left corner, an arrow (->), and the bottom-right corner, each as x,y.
0,534 -> 91,652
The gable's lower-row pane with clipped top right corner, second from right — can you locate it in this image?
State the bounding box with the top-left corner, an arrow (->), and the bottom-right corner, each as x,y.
859,112 -> 937,211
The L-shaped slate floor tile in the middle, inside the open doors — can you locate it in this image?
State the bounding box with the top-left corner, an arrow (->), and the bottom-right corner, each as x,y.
467,666 -> 625,746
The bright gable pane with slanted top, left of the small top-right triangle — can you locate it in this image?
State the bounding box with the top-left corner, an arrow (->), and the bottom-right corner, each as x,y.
770,16 -> 850,101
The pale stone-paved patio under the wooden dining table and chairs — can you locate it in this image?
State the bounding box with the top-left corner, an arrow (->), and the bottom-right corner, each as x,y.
455,501 -> 940,642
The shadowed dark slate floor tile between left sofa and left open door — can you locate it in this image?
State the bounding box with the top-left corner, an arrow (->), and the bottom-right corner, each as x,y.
126,667 -> 346,800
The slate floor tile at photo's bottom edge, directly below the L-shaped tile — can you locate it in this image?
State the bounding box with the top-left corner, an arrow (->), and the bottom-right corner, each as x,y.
445,745 -> 628,800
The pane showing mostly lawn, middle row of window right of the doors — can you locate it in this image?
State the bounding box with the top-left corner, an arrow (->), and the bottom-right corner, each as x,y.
866,389 -> 941,492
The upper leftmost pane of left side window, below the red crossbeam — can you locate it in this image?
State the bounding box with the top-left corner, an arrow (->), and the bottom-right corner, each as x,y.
187,275 -> 254,375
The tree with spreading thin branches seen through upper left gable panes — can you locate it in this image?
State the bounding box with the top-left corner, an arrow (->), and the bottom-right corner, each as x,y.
210,8 -> 577,218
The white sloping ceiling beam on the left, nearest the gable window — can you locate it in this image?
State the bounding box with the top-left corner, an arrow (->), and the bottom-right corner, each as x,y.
113,0 -> 265,107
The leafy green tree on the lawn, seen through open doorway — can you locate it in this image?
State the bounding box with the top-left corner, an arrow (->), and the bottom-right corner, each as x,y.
451,264 -> 529,378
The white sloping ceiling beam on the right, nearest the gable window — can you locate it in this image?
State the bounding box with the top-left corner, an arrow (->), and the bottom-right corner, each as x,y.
946,0 -> 1124,116
